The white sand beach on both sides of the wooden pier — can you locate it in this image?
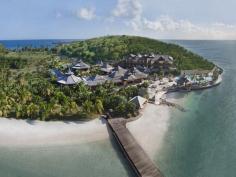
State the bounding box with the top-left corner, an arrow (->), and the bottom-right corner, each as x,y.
0,97 -> 176,157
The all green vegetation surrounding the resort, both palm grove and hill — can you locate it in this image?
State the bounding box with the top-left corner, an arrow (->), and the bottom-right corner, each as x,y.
0,36 -> 217,120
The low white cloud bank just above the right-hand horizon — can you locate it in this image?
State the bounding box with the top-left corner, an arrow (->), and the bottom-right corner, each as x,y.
140,16 -> 236,39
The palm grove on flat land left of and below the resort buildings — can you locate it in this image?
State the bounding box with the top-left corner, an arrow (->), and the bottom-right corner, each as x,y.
0,44 -> 146,120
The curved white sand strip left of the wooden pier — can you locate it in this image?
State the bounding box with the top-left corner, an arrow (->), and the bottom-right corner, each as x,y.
0,118 -> 109,146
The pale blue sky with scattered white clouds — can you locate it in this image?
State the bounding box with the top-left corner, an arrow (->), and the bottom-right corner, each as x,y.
0,0 -> 236,40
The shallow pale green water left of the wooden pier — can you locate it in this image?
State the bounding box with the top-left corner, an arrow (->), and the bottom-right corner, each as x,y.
0,141 -> 134,177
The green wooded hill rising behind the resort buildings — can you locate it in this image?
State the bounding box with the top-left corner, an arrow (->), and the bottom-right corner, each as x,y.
58,36 -> 214,70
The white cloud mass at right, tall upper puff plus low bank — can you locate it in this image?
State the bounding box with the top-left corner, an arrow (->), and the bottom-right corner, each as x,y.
111,0 -> 236,39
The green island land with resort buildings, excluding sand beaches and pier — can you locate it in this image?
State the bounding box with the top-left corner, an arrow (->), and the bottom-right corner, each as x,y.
0,35 -> 222,121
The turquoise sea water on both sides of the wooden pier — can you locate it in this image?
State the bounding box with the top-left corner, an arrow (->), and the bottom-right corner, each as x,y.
0,41 -> 236,177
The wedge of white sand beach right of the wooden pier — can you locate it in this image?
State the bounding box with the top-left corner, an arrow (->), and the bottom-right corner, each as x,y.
127,104 -> 170,158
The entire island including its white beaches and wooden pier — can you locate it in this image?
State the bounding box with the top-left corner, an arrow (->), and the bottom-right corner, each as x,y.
0,35 -> 223,177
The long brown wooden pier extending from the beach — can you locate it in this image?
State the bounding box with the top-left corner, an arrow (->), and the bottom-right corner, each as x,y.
107,118 -> 163,177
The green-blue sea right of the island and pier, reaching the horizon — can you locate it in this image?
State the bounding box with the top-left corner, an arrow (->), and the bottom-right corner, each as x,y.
156,41 -> 236,177
